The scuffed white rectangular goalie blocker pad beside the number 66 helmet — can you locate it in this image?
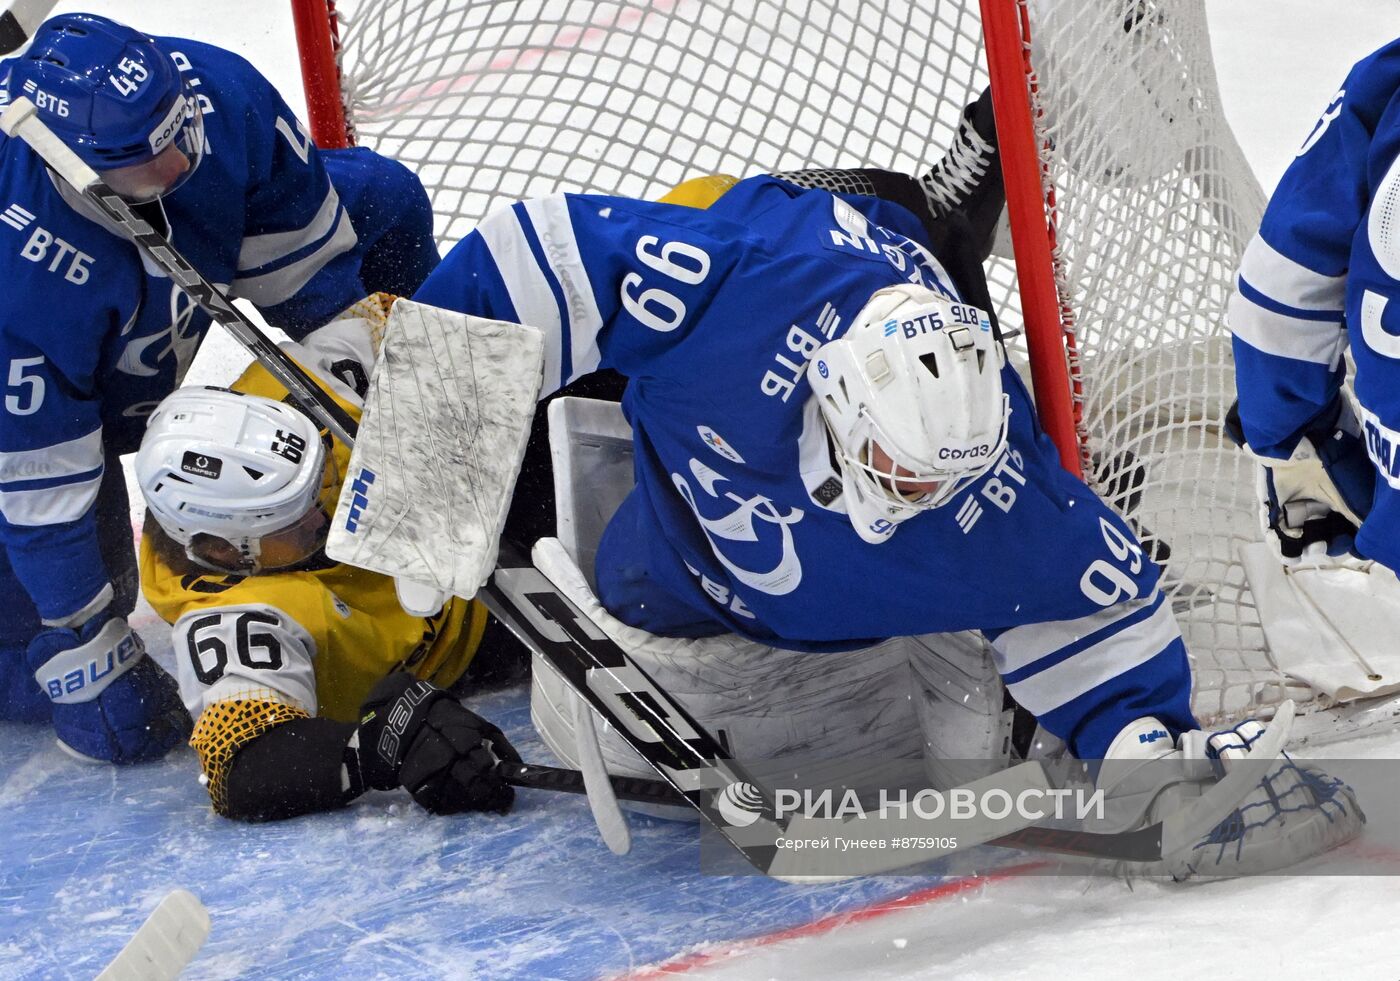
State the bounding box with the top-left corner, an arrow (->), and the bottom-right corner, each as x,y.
326,299 -> 545,598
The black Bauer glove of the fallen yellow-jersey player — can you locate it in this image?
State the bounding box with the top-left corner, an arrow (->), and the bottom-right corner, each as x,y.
356,672 -> 521,814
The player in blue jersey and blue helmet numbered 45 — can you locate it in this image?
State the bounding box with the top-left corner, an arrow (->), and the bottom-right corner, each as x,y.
0,14 -> 437,763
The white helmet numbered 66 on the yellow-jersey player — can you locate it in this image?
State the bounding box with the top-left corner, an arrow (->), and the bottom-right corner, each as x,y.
136,388 -> 326,572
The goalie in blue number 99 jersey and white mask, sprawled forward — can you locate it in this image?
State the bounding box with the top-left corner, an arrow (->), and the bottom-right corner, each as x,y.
416,112 -> 1359,868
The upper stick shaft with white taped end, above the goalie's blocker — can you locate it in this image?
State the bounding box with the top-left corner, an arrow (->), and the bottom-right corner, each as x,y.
0,97 -> 357,446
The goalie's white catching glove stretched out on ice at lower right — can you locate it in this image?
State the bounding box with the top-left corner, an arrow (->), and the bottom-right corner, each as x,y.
1098,718 -> 1366,882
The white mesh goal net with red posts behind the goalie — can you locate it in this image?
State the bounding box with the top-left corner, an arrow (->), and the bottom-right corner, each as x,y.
293,0 -> 1327,722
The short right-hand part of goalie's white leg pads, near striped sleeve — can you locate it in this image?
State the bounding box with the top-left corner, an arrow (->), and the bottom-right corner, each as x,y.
906,631 -> 1014,791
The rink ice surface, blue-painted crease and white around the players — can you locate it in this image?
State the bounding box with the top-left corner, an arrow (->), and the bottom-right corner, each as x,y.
0,0 -> 1400,981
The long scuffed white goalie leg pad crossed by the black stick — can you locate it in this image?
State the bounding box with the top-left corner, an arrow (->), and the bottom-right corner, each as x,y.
531,539 -> 921,811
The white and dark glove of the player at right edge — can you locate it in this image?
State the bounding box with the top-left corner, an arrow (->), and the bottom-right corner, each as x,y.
1225,396 -> 1376,565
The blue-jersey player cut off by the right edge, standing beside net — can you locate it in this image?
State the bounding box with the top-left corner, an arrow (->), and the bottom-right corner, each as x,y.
1229,42 -> 1400,570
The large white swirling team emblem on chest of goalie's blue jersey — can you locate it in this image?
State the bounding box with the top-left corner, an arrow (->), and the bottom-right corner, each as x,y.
671,458 -> 802,596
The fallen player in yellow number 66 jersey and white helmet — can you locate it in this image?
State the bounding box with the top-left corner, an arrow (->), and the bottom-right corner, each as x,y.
136,302 -> 518,820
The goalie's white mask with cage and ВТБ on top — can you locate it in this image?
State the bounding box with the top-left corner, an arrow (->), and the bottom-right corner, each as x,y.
808,284 -> 1011,543
